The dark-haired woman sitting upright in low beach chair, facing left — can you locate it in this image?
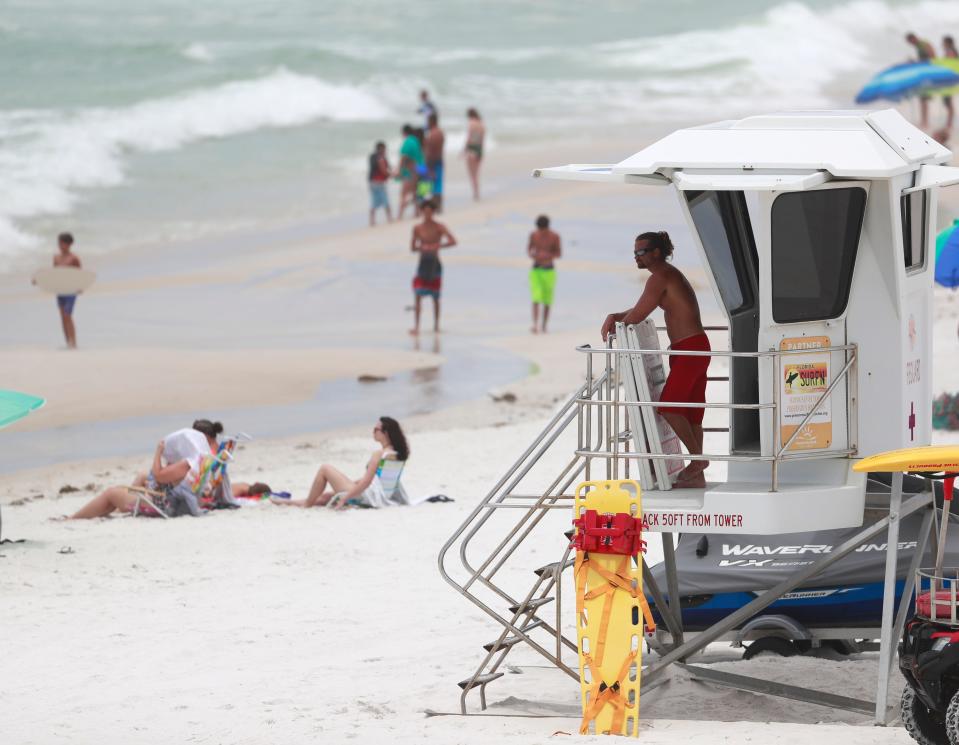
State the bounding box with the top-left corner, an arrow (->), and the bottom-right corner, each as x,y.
278,416 -> 410,510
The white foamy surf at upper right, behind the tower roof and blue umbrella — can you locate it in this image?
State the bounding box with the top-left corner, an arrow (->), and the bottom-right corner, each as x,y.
592,0 -> 959,113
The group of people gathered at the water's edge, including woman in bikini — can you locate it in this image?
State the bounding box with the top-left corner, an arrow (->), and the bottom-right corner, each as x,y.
367,90 -> 486,227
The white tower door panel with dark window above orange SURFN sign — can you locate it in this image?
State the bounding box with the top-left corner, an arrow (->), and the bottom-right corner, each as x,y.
757,181 -> 868,453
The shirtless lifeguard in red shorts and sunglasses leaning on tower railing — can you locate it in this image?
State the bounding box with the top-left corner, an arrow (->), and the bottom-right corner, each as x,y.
602,231 -> 710,489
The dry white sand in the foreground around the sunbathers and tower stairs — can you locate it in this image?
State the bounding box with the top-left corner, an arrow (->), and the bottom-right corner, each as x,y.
0,332 -> 924,745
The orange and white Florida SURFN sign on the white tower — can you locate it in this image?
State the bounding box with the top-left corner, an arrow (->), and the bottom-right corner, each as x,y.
779,336 -> 832,452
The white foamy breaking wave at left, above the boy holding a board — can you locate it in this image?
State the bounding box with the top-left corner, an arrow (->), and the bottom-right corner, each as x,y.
0,69 -> 391,254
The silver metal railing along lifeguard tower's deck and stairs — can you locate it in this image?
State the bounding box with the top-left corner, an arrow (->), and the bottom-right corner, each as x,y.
438,327 -> 856,713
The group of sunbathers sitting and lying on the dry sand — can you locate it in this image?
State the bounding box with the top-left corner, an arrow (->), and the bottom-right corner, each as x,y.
68,416 -> 410,520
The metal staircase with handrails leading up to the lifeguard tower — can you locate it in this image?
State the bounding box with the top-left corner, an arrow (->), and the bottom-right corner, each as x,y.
439,356 -> 613,714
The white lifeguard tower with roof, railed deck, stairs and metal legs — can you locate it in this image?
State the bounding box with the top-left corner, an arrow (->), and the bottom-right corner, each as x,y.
439,110 -> 959,723
